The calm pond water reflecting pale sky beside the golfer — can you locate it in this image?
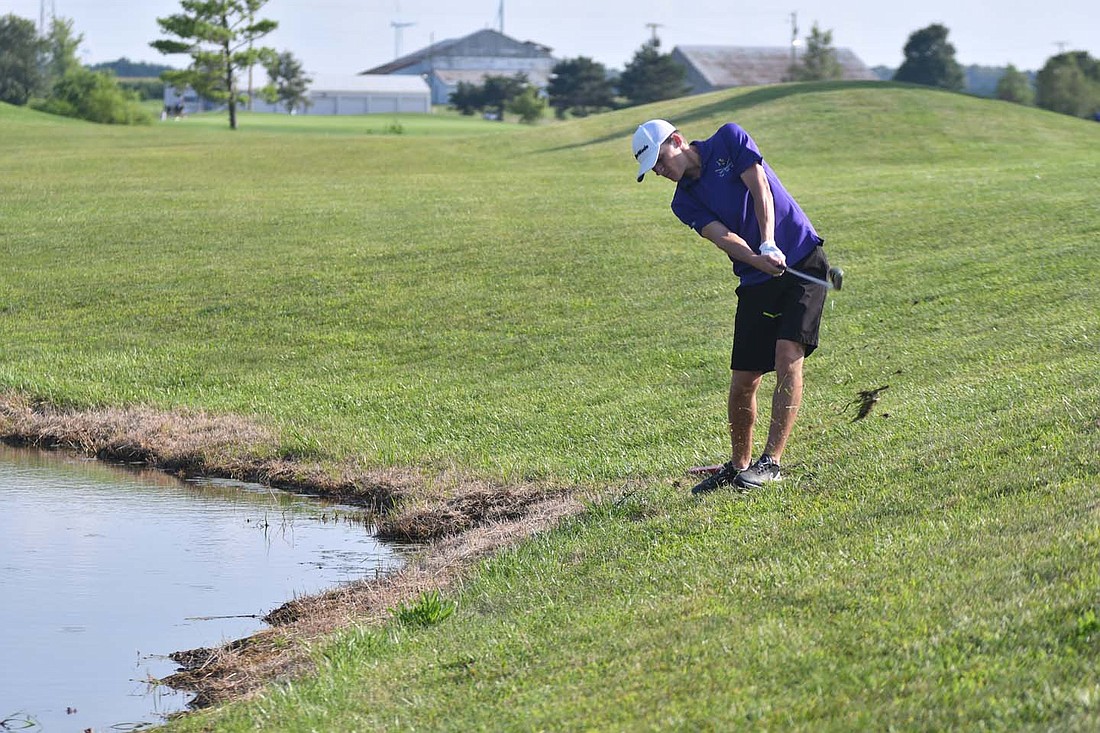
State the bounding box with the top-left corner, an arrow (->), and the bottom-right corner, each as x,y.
0,444 -> 402,732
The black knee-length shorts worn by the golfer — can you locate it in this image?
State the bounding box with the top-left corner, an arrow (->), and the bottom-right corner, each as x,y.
729,247 -> 828,372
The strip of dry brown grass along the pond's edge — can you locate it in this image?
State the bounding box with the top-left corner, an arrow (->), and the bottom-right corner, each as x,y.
0,393 -> 581,707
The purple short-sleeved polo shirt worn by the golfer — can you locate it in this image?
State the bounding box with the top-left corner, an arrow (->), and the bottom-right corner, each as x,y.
672,122 -> 825,285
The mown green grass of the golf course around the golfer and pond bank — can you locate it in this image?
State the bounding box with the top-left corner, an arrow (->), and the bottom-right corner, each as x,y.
0,85 -> 1100,730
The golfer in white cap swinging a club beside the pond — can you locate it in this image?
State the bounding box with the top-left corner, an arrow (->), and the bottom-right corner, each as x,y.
631,120 -> 828,494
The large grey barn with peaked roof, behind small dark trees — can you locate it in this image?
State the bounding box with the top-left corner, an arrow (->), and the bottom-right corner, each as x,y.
364,29 -> 558,105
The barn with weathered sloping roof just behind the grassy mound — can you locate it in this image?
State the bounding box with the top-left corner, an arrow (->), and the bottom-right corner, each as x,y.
671,46 -> 878,95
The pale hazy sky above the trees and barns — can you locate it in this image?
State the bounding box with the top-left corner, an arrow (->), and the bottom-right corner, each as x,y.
0,0 -> 1100,75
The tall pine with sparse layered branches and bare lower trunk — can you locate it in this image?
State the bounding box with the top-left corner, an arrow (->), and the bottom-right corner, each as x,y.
150,0 -> 278,130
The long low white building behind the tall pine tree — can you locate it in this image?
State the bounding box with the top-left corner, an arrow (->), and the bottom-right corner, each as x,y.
164,74 -> 431,116
